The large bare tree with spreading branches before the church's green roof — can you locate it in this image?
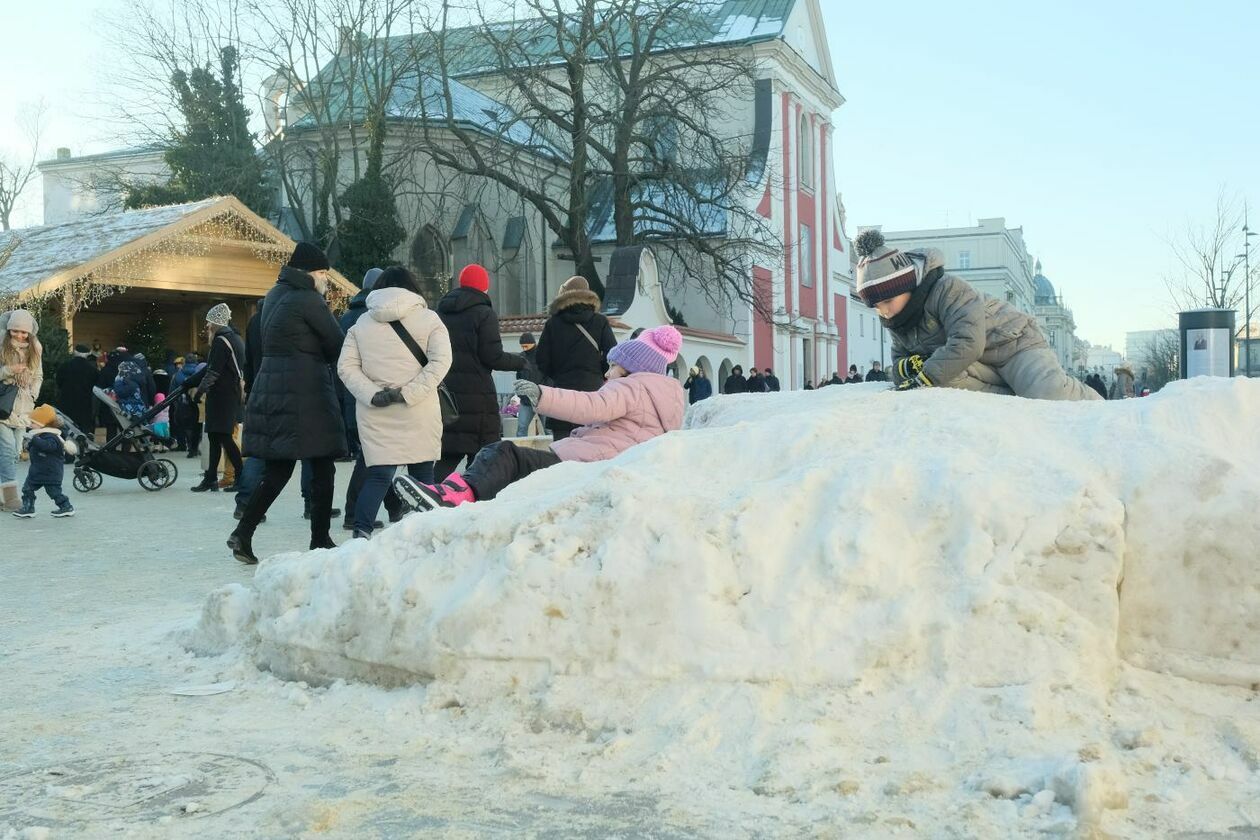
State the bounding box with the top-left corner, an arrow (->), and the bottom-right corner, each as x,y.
417,0 -> 781,316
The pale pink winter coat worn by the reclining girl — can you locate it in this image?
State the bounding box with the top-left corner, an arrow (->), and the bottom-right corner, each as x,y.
538,373 -> 687,461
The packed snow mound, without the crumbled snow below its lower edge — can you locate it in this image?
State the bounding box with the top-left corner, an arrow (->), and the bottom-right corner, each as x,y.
194,380 -> 1260,690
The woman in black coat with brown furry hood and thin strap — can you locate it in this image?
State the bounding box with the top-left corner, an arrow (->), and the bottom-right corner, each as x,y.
537,277 -> 617,441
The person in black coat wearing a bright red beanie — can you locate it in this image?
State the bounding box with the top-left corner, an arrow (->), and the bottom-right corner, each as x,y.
433,263 -> 525,481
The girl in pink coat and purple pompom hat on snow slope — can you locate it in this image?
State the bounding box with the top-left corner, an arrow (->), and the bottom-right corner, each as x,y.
394,326 -> 687,510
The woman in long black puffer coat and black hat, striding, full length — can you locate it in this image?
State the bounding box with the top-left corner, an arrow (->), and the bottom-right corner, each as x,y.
228,242 -> 345,563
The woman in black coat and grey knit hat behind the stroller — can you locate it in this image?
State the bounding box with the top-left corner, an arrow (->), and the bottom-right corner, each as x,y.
190,304 -> 244,492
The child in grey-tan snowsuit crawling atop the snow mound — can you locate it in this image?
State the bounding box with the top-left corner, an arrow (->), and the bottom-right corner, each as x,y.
857,230 -> 1099,399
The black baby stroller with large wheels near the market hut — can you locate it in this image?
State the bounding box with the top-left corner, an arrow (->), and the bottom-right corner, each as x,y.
66,387 -> 185,492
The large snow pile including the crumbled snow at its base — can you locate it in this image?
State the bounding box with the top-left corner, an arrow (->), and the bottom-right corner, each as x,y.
190,380 -> 1260,836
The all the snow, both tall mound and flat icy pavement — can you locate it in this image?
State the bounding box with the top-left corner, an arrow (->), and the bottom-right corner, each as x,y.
0,380 -> 1260,837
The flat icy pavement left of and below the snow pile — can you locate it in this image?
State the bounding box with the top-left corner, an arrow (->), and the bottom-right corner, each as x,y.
0,462 -> 745,839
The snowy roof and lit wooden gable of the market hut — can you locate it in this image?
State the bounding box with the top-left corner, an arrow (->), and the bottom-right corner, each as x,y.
0,196 -> 355,353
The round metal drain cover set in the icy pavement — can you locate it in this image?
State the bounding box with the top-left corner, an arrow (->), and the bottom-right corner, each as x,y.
0,753 -> 276,825
